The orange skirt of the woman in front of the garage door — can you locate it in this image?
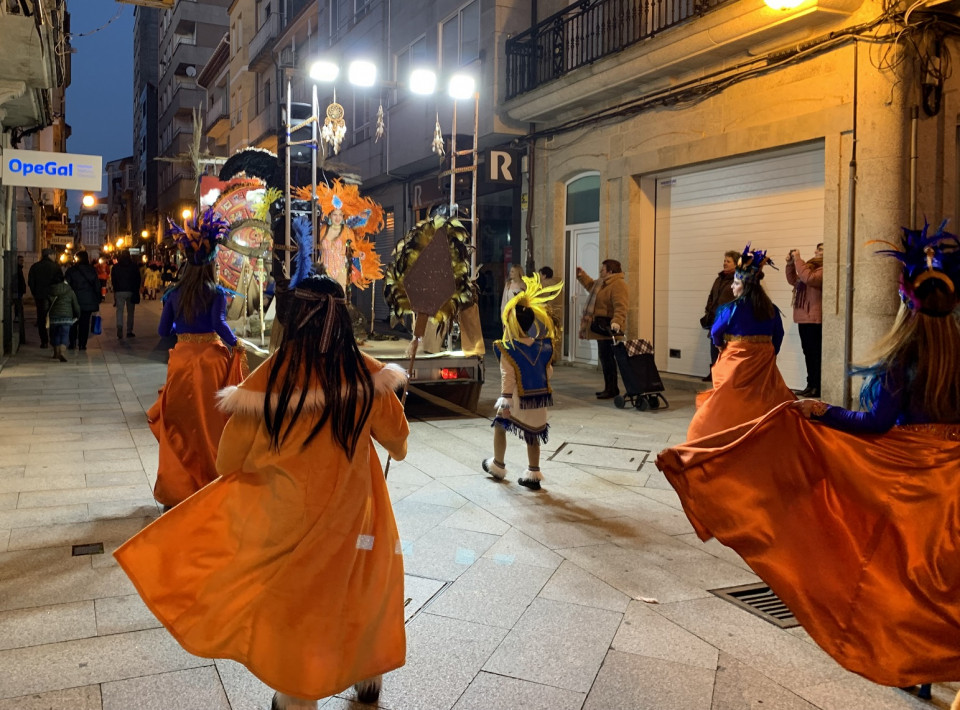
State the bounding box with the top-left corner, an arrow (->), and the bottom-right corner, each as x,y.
687,340 -> 797,441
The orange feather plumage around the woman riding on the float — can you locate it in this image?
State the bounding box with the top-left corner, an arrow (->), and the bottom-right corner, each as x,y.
294,180 -> 383,290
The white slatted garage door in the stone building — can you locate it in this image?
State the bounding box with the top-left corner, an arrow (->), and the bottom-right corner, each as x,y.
655,144 -> 824,388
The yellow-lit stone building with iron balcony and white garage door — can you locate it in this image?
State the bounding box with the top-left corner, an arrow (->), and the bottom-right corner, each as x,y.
498,0 -> 960,401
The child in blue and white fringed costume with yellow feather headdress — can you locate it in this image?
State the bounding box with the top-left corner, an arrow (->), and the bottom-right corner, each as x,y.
482,274 -> 563,491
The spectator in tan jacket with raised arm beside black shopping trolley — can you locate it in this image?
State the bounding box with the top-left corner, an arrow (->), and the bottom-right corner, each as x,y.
577,259 -> 629,399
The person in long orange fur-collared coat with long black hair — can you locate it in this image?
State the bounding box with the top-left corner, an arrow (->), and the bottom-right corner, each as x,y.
115,235 -> 408,710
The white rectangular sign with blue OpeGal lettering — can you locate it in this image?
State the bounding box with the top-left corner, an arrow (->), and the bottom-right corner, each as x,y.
0,148 -> 103,192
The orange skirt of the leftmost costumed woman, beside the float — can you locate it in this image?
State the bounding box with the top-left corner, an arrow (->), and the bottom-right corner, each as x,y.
147,333 -> 248,506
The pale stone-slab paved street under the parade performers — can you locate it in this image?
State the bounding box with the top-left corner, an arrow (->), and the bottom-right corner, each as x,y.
0,302 -> 960,710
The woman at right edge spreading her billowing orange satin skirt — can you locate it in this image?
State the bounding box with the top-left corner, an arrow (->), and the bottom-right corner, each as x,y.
657,227 -> 960,687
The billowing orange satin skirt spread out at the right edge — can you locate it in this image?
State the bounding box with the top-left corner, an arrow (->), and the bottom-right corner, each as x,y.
657,405 -> 960,687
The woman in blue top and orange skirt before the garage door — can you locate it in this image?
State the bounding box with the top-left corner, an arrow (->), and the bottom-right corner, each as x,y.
687,244 -> 796,441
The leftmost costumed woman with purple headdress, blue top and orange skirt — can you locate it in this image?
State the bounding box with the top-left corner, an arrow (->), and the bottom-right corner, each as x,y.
147,209 -> 249,509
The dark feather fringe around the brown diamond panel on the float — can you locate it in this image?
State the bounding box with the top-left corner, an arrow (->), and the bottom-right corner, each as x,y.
383,216 -> 474,333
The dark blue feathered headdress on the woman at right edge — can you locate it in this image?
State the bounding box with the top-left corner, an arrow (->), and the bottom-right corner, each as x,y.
869,220 -> 960,316
